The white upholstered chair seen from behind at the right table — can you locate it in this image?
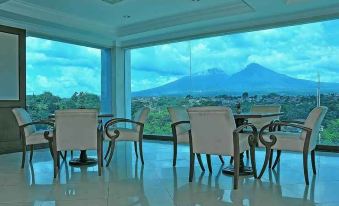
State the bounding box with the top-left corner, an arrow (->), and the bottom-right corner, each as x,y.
188,106 -> 257,189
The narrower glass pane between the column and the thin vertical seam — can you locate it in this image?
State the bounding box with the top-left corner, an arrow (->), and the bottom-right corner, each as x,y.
131,42 -> 190,135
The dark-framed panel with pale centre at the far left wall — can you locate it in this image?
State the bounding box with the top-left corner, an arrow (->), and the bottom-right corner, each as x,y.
0,26 -> 26,107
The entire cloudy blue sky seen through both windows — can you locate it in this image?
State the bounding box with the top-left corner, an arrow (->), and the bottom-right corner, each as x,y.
26,20 -> 339,97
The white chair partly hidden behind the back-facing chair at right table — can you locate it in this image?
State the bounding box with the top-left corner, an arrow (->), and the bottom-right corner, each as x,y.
167,106 -> 224,171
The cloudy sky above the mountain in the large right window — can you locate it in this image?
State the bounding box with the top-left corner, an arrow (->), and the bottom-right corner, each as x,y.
131,20 -> 339,91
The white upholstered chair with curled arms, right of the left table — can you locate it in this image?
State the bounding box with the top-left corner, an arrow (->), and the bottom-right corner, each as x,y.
105,107 -> 150,166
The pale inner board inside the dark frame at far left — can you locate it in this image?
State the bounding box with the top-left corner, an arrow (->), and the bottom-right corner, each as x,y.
0,32 -> 19,100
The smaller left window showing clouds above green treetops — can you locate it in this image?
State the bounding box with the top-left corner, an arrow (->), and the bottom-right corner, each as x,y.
26,37 -> 101,119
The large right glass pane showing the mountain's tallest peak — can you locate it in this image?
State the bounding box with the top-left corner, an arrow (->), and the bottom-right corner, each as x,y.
191,20 -> 339,144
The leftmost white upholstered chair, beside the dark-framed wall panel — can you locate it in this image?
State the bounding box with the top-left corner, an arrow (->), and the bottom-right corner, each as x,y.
12,108 -> 54,168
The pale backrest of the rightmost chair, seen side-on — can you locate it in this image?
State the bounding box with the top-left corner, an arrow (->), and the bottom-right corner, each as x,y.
301,106 -> 328,150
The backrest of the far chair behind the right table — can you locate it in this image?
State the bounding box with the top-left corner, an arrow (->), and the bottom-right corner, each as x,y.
248,105 -> 281,131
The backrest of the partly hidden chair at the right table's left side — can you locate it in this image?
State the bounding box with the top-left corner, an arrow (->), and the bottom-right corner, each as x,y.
167,106 -> 191,134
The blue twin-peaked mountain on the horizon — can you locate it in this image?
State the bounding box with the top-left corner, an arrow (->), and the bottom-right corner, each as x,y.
132,63 -> 339,96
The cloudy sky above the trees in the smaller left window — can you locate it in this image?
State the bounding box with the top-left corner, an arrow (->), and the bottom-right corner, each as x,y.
26,37 -> 101,97
